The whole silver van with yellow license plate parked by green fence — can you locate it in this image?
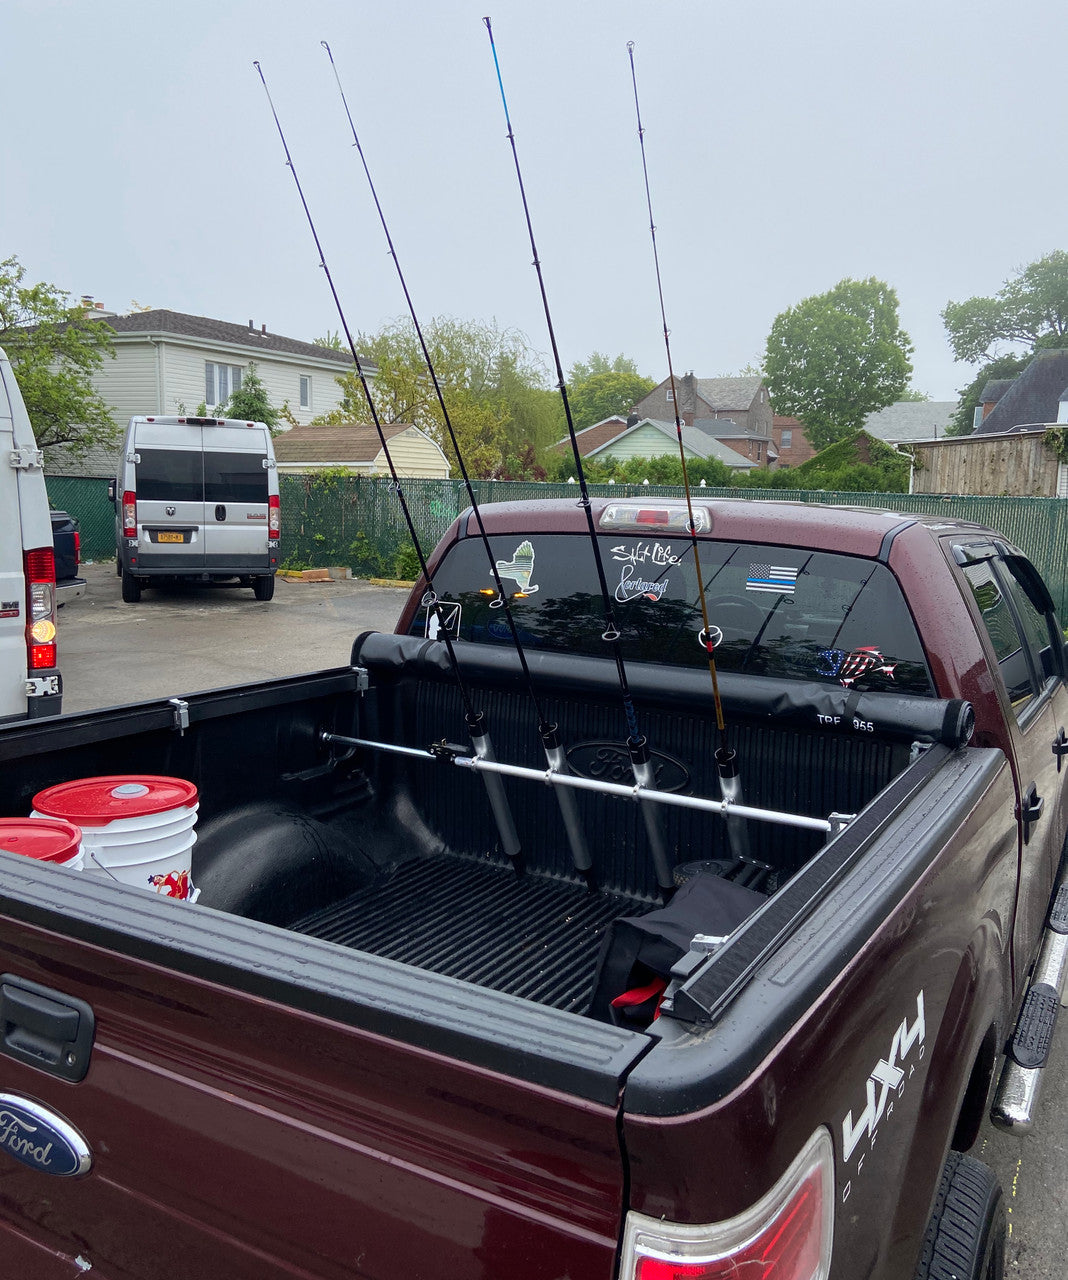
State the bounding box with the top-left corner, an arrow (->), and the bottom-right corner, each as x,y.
111,417 -> 282,604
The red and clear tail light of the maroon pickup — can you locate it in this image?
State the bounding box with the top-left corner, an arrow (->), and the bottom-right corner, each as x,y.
620,1129 -> 834,1280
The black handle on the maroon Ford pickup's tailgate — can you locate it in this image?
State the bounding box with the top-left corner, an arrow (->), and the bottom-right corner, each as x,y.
0,973 -> 96,1083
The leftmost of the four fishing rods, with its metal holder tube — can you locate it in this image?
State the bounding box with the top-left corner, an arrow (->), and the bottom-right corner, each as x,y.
252,61 -> 522,870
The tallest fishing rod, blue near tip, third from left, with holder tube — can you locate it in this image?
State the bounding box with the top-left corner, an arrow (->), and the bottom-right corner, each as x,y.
483,18 -> 675,893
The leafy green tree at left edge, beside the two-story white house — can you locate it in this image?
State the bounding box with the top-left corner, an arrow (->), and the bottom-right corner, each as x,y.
0,257 -> 119,454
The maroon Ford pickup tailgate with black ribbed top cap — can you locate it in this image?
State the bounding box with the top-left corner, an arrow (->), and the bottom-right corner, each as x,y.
0,855 -> 648,1280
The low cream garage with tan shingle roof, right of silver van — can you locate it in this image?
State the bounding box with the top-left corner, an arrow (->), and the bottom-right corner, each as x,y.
274,422 -> 449,480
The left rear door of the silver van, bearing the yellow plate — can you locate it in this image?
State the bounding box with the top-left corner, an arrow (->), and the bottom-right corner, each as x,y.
133,420 -> 206,573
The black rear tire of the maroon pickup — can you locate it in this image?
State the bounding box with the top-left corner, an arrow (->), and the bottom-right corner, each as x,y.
916,1151 -> 1005,1280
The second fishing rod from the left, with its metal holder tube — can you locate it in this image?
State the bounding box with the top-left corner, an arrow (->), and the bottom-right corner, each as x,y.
319,40 -> 593,887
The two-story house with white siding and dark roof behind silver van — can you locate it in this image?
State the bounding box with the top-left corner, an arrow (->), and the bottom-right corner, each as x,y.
84,306 -> 353,425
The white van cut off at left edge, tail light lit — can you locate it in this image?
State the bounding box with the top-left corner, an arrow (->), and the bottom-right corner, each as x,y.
0,349 -> 63,723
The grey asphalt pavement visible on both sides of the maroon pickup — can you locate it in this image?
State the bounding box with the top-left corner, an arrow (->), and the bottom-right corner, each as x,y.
49,563 -> 1068,1280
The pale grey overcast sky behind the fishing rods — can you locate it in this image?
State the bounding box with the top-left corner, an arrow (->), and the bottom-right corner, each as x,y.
0,0 -> 1068,399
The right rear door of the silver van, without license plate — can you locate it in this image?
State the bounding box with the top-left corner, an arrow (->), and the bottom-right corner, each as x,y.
204,425 -> 271,573
